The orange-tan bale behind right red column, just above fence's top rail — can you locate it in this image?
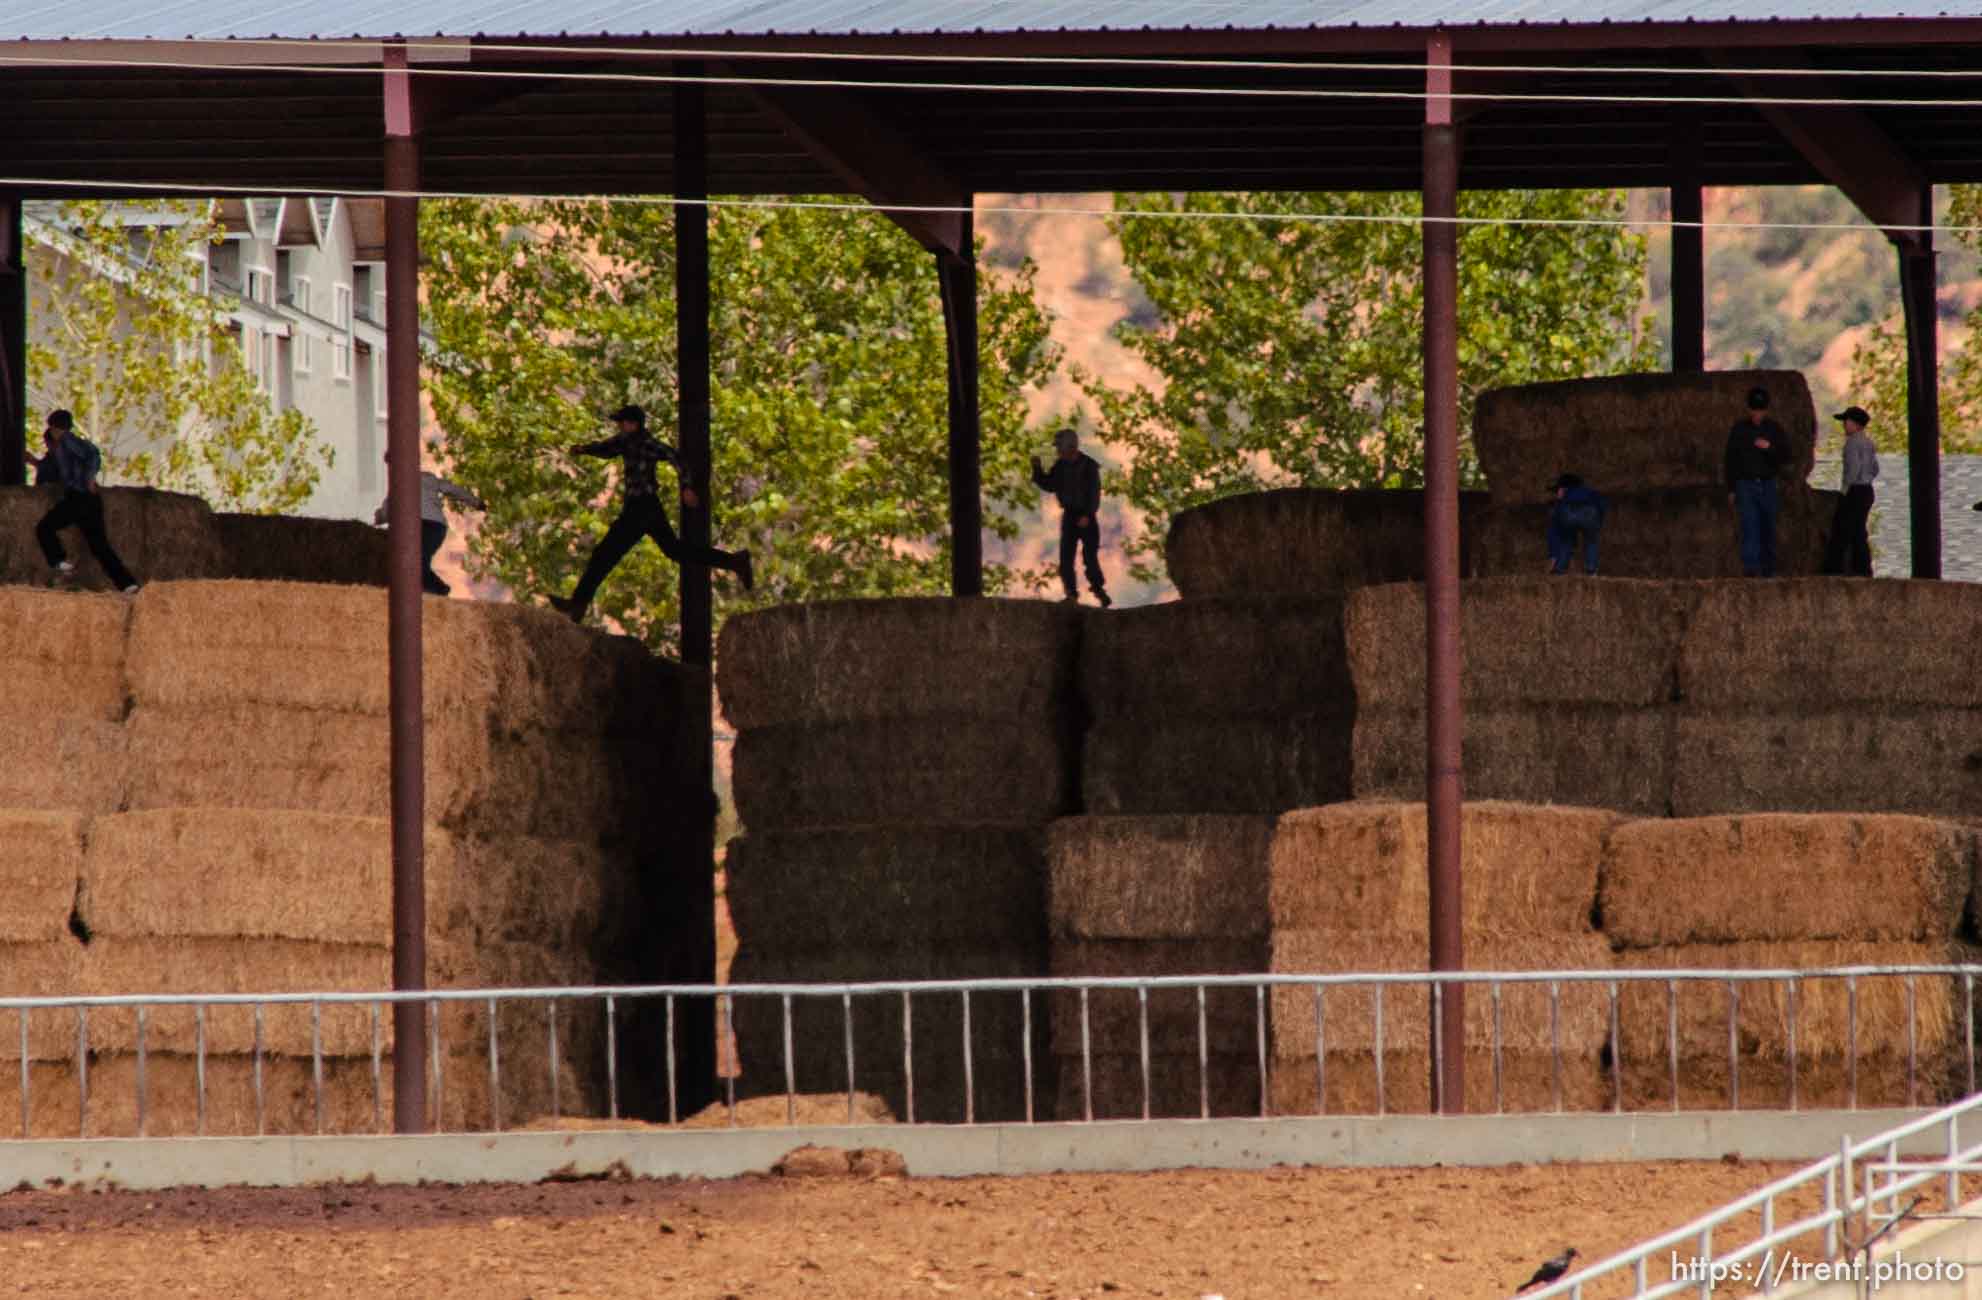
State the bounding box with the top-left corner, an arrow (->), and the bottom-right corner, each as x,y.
1268,803 -> 1619,935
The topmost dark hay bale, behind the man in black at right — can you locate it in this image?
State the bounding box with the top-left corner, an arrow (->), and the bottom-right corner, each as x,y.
1473,371 -> 1817,505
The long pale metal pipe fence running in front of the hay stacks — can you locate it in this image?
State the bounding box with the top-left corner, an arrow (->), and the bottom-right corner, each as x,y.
0,965 -> 1982,1138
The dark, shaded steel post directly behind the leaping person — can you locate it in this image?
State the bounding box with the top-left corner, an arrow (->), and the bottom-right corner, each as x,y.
666,61 -> 716,1100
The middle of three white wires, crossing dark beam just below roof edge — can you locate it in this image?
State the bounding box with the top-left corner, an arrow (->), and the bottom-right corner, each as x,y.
15,54 -> 1982,111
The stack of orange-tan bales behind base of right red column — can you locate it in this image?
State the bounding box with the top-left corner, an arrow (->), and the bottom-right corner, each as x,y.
1270,803 -> 1617,1114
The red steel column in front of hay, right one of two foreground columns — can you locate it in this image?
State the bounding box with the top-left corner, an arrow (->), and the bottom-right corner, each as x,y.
1423,32 -> 1467,1114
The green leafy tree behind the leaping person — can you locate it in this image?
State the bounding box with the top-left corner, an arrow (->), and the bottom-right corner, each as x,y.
420,200 -> 1056,650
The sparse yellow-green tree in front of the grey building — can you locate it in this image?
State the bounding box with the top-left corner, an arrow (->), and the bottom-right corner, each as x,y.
28,200 -> 333,513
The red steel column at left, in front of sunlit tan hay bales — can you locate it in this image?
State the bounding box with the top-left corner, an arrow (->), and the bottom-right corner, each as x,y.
385,46 -> 438,1134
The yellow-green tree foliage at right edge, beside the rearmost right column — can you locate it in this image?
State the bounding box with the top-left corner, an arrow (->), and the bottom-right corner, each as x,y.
1823,184 -> 1982,456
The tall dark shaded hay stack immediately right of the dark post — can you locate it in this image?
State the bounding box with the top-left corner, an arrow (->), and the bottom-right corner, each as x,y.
717,600 -> 1080,1120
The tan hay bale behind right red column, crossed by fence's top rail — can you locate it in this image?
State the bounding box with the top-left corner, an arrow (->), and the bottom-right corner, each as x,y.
1270,929 -> 1613,1060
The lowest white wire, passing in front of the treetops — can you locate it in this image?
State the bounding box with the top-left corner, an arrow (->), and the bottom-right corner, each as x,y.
0,176 -> 1982,236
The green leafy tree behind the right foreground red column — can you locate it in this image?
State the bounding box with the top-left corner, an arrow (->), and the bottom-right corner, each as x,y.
1082,190 -> 1657,577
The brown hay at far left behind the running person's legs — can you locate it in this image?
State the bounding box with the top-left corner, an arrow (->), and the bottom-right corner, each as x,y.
0,488 -> 224,591
